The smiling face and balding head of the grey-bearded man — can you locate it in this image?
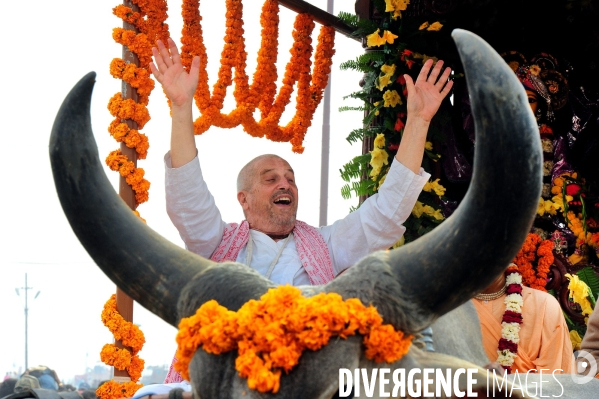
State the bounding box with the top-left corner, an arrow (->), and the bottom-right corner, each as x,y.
237,156 -> 298,235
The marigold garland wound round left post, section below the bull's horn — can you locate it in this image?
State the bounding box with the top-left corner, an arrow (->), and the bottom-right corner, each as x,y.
96,294 -> 146,399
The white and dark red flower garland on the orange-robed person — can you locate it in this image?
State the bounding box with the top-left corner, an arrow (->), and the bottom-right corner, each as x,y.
497,263 -> 524,373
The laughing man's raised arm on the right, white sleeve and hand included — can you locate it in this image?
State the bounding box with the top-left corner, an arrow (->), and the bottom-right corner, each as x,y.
321,60 -> 453,273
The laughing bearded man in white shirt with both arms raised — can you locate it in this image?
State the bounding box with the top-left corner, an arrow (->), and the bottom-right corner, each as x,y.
144,39 -> 453,390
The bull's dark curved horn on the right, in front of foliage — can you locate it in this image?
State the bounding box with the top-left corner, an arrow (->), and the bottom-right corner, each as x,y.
389,29 -> 542,318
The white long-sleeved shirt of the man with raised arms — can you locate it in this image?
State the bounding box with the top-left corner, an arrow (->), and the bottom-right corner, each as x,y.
164,153 -> 430,286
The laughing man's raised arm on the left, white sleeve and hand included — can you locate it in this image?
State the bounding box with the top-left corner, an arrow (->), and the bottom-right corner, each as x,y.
150,39 -> 225,257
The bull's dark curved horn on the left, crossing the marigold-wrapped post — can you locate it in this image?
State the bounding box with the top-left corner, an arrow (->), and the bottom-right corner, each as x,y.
50,72 -> 213,327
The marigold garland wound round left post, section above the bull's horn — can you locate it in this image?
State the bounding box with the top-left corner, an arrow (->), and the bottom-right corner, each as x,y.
106,0 -> 169,212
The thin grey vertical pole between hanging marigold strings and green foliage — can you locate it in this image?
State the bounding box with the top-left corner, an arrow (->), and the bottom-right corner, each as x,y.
318,0 -> 335,226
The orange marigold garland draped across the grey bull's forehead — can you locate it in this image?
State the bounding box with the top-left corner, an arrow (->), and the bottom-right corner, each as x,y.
175,286 -> 412,393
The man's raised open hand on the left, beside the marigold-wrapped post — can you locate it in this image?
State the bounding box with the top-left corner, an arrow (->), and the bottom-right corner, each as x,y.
150,38 -> 200,107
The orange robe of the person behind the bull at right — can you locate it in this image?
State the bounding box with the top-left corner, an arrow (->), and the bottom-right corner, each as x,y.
472,287 -> 574,374
